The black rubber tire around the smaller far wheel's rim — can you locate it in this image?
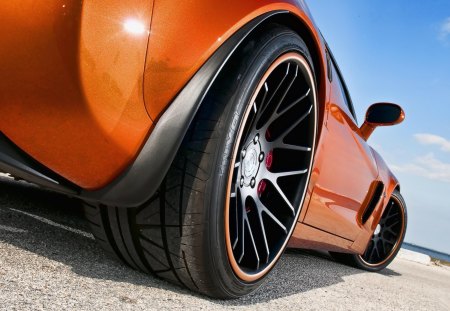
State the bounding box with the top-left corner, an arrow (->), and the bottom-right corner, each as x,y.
330,190 -> 408,272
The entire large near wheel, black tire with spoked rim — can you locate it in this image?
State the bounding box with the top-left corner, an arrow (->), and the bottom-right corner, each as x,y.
86,25 -> 317,298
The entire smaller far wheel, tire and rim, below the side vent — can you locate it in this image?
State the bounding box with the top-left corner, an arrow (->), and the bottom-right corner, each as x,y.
330,190 -> 408,272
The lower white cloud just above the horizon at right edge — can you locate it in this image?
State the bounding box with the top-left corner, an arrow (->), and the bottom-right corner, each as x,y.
392,153 -> 450,183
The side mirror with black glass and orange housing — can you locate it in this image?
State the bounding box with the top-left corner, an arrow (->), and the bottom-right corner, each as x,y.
360,103 -> 405,140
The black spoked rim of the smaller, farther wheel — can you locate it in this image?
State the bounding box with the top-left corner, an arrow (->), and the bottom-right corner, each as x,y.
359,197 -> 405,266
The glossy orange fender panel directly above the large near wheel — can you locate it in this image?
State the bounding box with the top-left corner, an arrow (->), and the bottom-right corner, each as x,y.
145,0 -> 325,120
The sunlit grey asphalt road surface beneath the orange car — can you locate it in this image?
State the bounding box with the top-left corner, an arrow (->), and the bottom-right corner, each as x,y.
0,178 -> 450,311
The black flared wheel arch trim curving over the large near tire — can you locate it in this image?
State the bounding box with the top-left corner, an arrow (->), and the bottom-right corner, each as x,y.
80,10 -> 326,207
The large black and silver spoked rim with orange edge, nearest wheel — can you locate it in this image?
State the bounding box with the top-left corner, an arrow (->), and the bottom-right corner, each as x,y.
225,53 -> 317,281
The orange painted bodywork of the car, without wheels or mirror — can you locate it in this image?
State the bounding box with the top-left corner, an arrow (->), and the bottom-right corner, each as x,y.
0,0 -> 398,253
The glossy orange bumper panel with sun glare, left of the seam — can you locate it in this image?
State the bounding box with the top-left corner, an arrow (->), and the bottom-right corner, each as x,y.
0,0 -> 152,189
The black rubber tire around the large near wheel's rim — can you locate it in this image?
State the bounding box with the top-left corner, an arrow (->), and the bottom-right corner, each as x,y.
85,25 -> 312,298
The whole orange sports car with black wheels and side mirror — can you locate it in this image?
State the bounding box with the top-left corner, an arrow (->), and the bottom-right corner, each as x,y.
0,0 -> 406,298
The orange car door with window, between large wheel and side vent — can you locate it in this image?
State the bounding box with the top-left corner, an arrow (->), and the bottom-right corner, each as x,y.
303,54 -> 378,241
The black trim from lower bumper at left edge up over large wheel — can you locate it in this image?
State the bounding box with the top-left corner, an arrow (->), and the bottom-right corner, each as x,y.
0,10 -> 321,207
